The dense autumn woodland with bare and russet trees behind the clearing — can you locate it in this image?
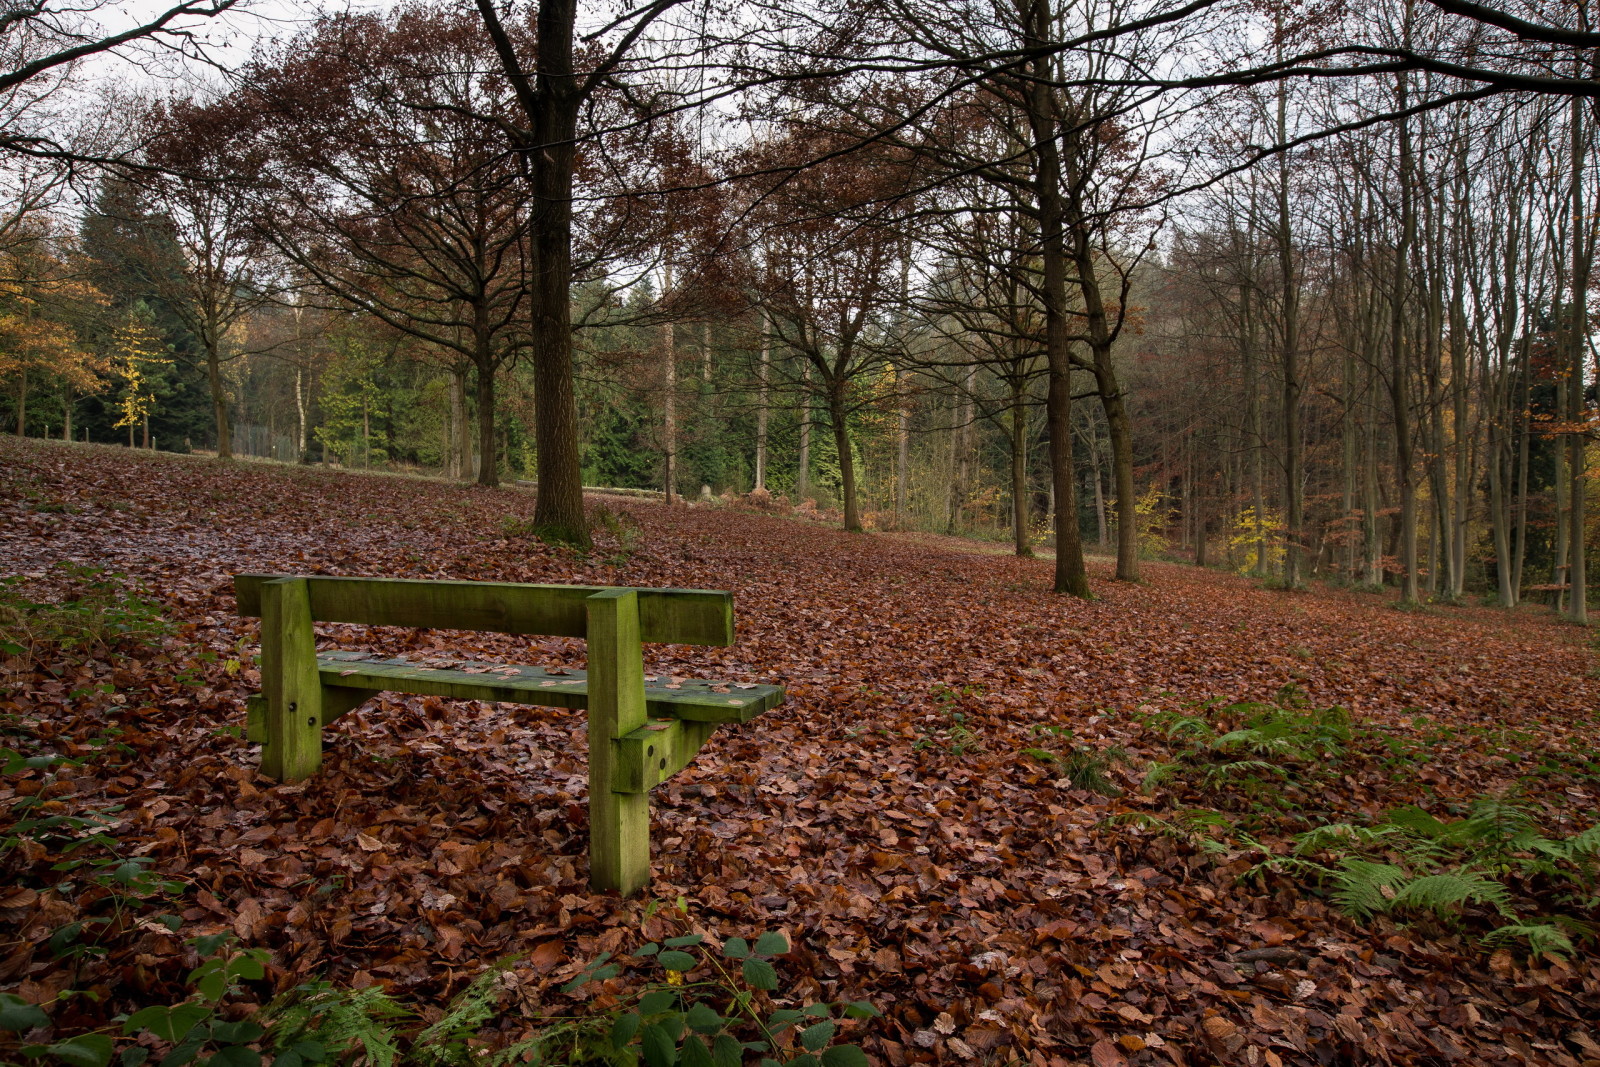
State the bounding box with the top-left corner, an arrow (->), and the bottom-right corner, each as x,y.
9,0 -> 1600,607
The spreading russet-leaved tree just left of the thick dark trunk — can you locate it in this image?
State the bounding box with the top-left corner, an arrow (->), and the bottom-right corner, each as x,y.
236,6 -> 533,485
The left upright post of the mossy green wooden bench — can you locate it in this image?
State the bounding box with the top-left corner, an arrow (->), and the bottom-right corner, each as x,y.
261,577 -> 322,781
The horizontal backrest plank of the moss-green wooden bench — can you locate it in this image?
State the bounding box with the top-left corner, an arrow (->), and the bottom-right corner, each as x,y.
234,574 -> 733,645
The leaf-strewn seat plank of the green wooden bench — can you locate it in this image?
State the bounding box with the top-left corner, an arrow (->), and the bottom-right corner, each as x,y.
317,653 -> 784,723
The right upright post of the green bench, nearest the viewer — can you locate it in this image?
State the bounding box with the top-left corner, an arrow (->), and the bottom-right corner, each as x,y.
586,589 -> 650,894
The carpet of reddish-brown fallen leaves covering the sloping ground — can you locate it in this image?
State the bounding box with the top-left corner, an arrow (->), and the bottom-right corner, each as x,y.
0,438 -> 1600,1067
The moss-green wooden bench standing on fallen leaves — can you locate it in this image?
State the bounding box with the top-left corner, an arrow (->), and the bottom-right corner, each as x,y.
234,574 -> 784,893
